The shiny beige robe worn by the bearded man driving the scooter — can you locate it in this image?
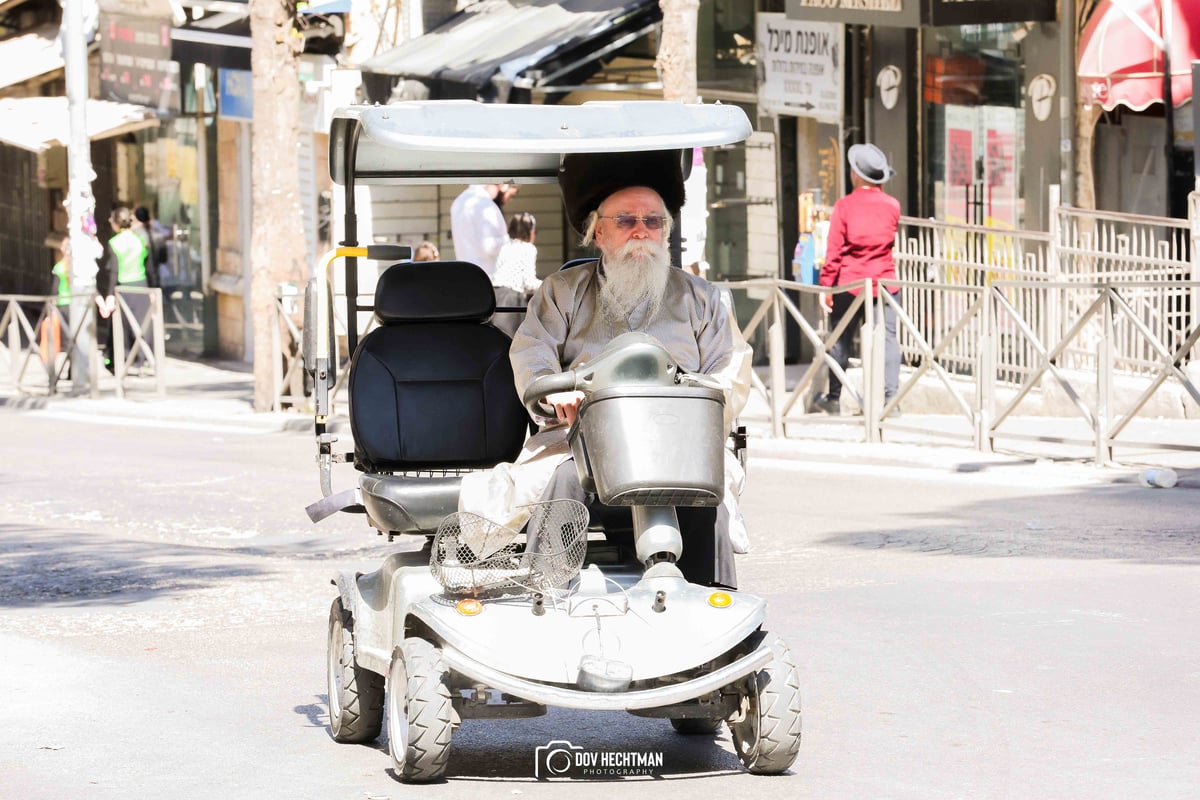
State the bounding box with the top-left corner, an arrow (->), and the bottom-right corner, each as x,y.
458,264 -> 752,553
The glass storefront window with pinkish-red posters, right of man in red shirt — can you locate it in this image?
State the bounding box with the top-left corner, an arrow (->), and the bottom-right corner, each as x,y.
923,24 -> 1028,229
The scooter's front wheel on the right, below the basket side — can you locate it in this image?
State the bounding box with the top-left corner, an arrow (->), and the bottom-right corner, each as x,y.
730,636 -> 800,775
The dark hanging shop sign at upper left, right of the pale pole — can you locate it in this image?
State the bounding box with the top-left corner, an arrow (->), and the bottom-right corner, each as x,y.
100,14 -> 180,114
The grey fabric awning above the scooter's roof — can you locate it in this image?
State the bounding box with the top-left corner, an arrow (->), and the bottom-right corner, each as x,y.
360,0 -> 662,103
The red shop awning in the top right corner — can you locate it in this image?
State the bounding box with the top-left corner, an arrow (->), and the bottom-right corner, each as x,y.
1079,0 -> 1200,112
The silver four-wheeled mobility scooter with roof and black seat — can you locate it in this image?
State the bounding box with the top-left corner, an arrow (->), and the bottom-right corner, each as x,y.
304,101 -> 800,782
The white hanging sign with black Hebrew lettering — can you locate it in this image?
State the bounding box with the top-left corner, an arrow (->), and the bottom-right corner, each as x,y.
757,13 -> 845,122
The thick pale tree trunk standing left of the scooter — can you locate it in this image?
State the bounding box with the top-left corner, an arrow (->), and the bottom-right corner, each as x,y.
250,0 -> 307,411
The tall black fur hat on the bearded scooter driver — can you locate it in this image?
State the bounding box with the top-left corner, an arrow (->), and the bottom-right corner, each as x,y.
558,150 -> 691,233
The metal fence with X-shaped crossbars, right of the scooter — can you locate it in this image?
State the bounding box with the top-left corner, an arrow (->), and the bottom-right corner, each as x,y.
705,278 -> 1200,464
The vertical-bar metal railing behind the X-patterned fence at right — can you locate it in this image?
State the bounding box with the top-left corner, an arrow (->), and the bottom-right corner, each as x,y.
894,191 -> 1200,379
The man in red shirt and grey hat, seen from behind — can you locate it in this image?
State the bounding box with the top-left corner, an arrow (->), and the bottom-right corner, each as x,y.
814,144 -> 900,414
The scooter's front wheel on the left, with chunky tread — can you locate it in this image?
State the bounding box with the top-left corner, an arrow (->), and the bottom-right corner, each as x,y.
388,638 -> 454,783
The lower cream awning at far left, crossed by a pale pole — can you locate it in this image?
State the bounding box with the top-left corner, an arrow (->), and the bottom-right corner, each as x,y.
0,97 -> 158,152
